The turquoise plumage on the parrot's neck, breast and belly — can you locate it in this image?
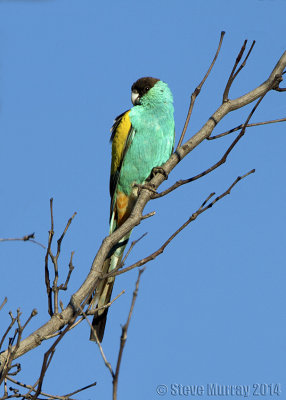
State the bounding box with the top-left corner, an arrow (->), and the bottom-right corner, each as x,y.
118,81 -> 175,195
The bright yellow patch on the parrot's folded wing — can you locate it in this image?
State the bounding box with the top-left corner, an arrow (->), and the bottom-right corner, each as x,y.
111,111 -> 131,175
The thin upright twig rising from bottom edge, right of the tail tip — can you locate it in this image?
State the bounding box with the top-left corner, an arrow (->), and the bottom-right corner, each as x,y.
113,268 -> 145,400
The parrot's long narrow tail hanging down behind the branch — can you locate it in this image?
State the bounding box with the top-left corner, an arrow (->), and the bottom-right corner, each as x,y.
89,232 -> 131,342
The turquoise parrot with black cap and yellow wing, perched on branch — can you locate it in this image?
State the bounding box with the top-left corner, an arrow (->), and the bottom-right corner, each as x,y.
90,77 -> 175,342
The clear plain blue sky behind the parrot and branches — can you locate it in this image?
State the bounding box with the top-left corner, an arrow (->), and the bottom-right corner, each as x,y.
0,0 -> 286,400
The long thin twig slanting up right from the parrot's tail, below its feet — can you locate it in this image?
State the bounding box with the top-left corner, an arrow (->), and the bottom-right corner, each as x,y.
103,169 -> 255,279
